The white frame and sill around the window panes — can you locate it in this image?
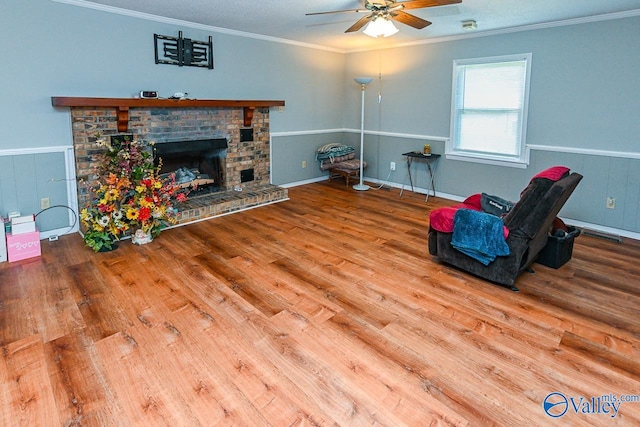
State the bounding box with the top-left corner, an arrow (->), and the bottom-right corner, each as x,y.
445,53 -> 532,168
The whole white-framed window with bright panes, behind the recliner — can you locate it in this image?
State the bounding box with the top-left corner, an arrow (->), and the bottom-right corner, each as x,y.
446,53 -> 531,167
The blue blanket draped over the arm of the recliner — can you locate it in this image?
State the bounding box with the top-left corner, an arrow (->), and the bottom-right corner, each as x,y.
451,209 -> 509,265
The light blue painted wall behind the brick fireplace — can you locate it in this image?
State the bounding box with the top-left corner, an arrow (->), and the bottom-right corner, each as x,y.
0,0 -> 346,231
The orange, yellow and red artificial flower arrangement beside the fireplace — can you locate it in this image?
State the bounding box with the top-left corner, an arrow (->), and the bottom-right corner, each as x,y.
80,135 -> 187,252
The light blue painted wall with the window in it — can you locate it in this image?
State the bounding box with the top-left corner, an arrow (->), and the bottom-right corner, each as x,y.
344,17 -> 640,235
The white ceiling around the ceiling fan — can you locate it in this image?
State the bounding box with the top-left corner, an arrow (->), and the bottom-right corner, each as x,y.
67,0 -> 640,51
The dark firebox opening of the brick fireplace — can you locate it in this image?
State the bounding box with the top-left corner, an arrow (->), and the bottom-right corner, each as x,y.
153,138 -> 228,197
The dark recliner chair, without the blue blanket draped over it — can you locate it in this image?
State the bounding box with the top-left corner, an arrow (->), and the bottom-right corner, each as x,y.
429,166 -> 582,292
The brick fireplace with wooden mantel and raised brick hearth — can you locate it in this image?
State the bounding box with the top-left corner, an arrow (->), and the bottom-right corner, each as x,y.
52,98 -> 288,224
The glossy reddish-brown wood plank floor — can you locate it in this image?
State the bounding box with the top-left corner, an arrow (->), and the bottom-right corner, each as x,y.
0,182 -> 640,426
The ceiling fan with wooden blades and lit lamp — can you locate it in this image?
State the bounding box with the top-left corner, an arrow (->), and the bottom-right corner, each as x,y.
306,0 -> 462,35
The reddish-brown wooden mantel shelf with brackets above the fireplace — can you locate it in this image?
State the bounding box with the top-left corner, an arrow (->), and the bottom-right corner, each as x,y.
51,96 -> 284,132
